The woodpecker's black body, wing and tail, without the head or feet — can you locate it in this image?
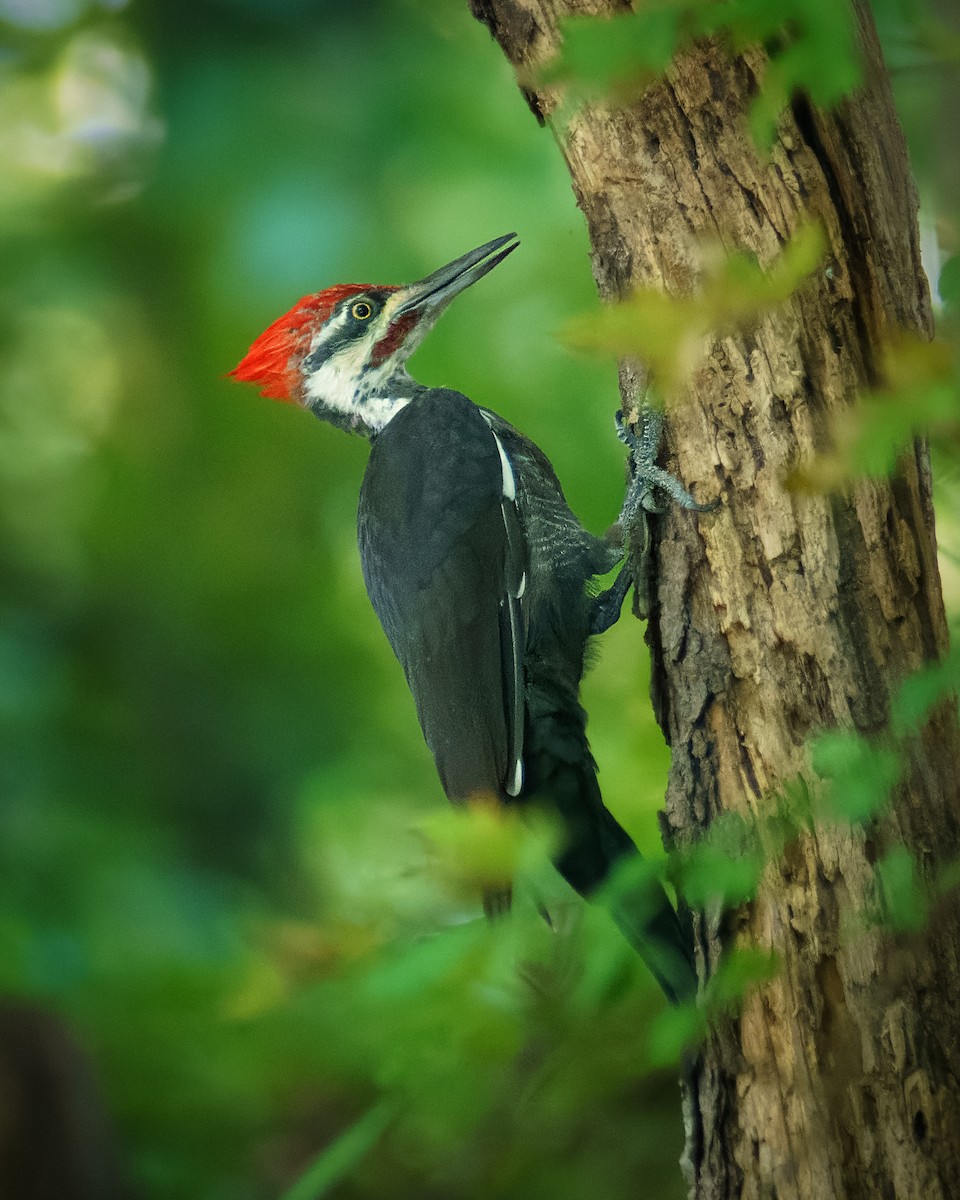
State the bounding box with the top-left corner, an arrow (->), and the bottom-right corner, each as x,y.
358,390 -> 696,1000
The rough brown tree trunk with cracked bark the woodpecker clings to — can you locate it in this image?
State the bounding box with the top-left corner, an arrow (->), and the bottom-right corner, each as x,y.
473,0 -> 960,1200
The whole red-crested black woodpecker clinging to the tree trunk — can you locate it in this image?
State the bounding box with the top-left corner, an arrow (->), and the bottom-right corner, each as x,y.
230,234 -> 702,1001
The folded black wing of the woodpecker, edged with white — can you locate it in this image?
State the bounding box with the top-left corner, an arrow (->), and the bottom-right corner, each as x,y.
358,390 -> 526,800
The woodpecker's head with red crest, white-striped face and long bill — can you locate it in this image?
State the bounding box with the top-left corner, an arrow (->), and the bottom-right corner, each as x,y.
230,233 -> 518,434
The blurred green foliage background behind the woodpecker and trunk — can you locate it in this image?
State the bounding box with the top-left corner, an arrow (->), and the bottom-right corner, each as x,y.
0,0 -> 958,1200
